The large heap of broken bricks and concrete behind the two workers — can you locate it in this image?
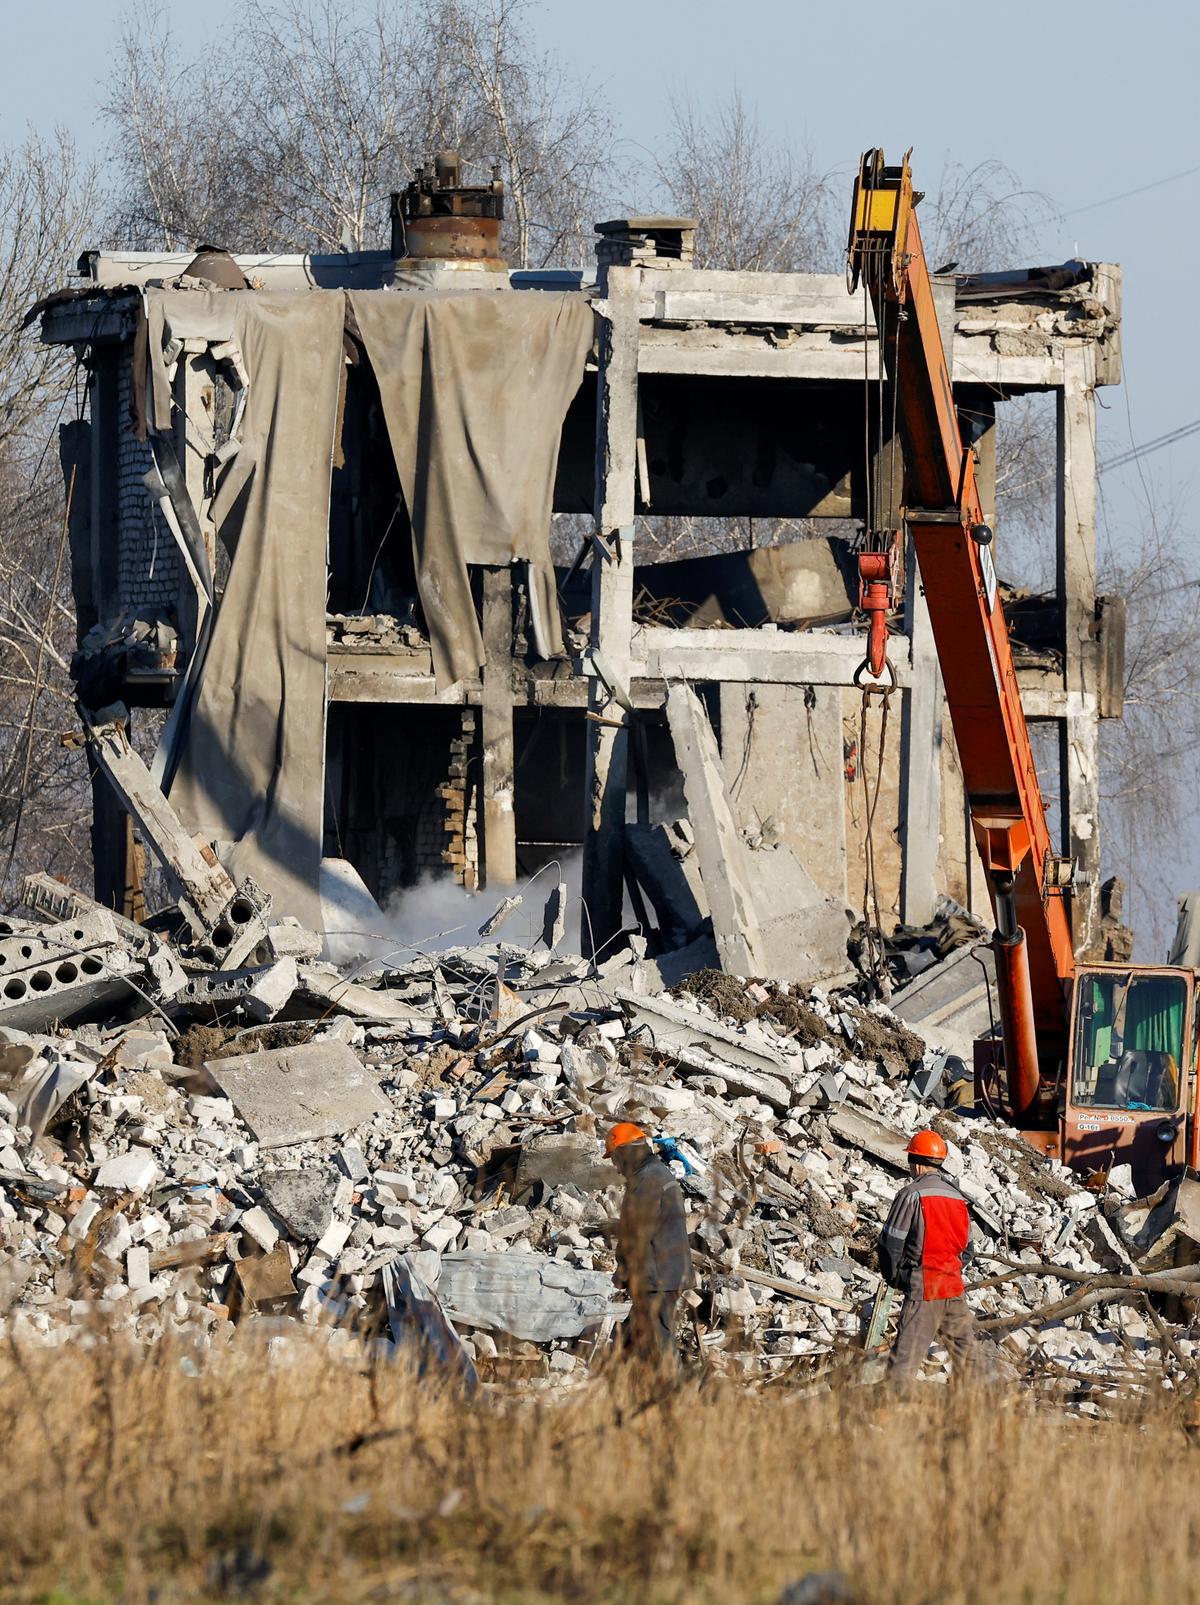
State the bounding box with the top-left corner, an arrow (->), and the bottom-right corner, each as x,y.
0,894 -> 1195,1380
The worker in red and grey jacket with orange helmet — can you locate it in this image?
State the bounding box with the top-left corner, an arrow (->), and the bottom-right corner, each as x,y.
879,1130 -> 975,1382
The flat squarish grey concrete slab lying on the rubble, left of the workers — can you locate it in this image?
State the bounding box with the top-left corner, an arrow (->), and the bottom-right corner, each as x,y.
205,1042 -> 391,1148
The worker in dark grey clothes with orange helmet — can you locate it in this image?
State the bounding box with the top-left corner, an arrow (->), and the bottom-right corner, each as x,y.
605,1120 -> 695,1369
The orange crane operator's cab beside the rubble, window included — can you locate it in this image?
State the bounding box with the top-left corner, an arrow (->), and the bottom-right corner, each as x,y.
1060,965 -> 1197,1196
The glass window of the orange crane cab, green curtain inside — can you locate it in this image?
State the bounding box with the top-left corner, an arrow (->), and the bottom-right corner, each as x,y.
1073,971 -> 1187,1111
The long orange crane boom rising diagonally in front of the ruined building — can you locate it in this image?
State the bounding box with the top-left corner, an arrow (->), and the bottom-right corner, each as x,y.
849,151 -> 1075,1124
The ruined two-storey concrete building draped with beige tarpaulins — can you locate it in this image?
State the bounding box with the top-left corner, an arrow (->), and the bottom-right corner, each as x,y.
42,159 -> 1123,974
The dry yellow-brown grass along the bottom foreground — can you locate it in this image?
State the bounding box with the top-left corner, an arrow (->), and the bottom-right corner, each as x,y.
0,1340 -> 1200,1605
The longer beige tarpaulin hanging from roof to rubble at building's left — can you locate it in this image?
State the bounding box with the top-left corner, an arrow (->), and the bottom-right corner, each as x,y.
146,291 -> 345,929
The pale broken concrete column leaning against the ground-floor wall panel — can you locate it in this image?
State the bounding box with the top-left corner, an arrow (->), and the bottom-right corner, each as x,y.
667,685 -> 765,976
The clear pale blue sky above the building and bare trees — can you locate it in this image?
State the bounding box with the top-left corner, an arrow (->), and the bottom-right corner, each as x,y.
0,0 -> 1200,937
